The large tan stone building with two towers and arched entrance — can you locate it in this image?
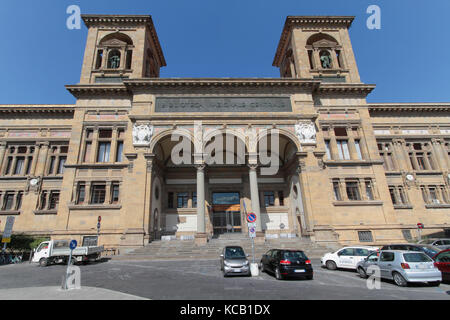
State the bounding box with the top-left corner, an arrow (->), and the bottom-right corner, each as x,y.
0,15 -> 450,247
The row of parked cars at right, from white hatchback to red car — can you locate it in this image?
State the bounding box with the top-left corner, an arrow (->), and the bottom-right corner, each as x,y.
321,239 -> 450,286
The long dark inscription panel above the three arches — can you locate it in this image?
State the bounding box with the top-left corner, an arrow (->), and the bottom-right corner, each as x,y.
155,97 -> 292,112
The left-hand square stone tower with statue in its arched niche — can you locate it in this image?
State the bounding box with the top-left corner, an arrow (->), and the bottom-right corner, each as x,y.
80,15 -> 166,84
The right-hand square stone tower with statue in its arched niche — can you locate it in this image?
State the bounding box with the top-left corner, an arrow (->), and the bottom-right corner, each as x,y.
273,16 -> 361,83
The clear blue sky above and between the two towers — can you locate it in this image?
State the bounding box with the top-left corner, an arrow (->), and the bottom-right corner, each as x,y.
0,0 -> 450,104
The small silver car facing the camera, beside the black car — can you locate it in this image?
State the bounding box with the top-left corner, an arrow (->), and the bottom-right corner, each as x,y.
220,246 -> 251,277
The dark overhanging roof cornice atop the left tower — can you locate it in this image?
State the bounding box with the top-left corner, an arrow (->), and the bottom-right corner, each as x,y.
81,14 -> 167,67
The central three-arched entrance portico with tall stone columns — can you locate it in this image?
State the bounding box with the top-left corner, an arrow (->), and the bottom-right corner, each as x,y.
143,124 -> 306,243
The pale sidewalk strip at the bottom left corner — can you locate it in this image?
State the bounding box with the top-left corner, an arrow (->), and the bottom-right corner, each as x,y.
0,287 -> 149,300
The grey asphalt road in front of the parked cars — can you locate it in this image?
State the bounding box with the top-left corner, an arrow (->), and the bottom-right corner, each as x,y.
0,260 -> 450,300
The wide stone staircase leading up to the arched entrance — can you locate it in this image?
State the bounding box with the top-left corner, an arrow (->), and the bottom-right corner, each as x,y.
114,235 -> 337,261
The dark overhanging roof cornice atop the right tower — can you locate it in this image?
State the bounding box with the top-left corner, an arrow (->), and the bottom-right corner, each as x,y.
273,16 -> 355,67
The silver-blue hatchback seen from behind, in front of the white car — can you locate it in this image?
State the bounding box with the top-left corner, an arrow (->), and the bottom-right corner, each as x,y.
356,250 -> 442,287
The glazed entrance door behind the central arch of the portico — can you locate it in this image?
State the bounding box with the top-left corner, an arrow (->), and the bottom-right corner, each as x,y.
213,192 -> 242,235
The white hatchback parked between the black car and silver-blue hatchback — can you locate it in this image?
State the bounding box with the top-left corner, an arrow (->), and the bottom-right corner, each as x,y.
320,246 -> 380,270
